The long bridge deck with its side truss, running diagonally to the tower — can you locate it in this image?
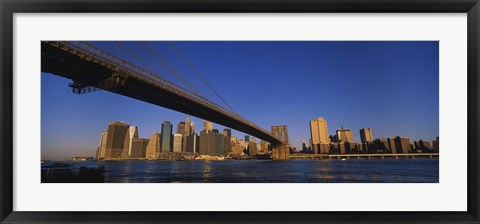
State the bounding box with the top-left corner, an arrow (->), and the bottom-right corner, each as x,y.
41,41 -> 282,144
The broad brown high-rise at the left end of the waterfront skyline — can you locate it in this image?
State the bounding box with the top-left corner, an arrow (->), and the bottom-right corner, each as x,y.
105,122 -> 130,160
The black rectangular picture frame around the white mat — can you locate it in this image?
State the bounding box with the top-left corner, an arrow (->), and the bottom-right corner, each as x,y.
0,0 -> 480,223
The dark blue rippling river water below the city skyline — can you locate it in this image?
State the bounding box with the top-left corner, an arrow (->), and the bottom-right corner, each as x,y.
63,158 -> 439,183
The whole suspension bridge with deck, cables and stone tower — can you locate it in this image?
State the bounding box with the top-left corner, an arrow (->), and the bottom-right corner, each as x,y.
41,41 -> 290,160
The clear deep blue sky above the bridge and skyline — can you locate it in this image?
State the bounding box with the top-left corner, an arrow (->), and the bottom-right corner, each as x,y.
41,41 -> 439,159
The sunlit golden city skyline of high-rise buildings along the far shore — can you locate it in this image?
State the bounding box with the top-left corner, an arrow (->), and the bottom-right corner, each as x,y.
89,117 -> 439,160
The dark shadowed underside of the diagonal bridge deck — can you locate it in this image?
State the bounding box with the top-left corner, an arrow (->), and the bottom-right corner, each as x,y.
41,42 -> 281,145
